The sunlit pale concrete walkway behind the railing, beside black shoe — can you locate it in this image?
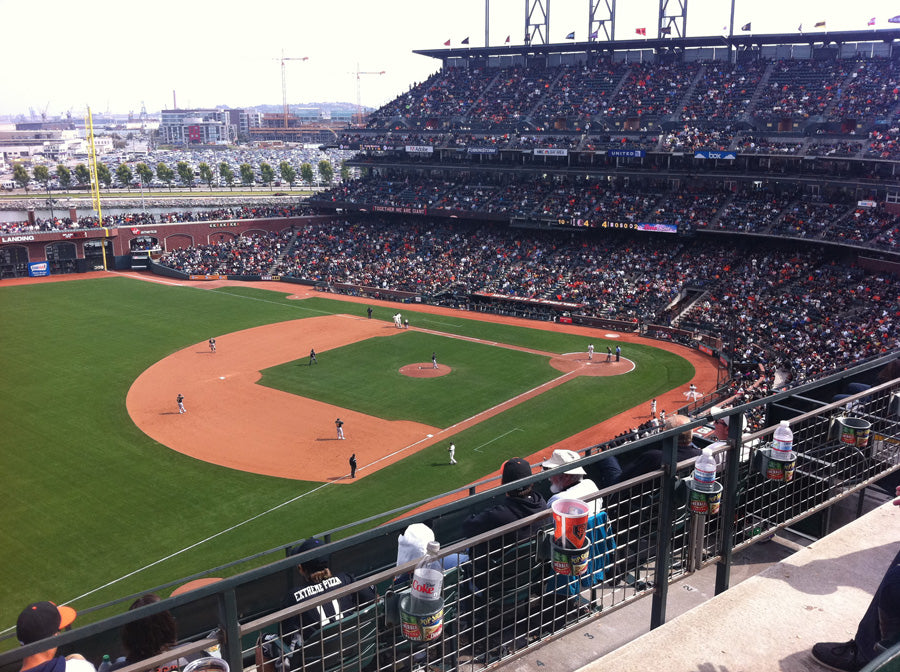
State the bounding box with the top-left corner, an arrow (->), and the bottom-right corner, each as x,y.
581,502 -> 900,672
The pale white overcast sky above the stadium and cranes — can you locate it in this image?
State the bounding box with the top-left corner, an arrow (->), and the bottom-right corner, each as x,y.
0,0 -> 900,117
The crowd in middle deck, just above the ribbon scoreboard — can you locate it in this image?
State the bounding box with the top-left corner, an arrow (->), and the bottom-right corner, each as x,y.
314,177 -> 900,249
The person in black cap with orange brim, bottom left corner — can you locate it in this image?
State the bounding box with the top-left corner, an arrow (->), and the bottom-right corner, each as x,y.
16,602 -> 96,672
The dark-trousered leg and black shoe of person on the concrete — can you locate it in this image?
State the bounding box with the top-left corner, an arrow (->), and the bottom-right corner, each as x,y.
812,486 -> 900,672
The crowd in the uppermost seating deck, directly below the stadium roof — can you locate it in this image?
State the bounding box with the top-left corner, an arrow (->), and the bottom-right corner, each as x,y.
370,56 -> 900,135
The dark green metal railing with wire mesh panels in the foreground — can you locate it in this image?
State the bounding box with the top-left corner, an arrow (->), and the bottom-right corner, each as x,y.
0,353 -> 900,672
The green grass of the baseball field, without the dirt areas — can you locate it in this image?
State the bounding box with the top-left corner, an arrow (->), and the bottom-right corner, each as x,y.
0,278 -> 693,630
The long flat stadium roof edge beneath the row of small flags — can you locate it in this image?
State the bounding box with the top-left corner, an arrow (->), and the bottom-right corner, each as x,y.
413,29 -> 900,60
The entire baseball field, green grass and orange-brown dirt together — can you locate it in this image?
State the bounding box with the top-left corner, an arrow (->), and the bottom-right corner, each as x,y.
0,274 -> 715,633
